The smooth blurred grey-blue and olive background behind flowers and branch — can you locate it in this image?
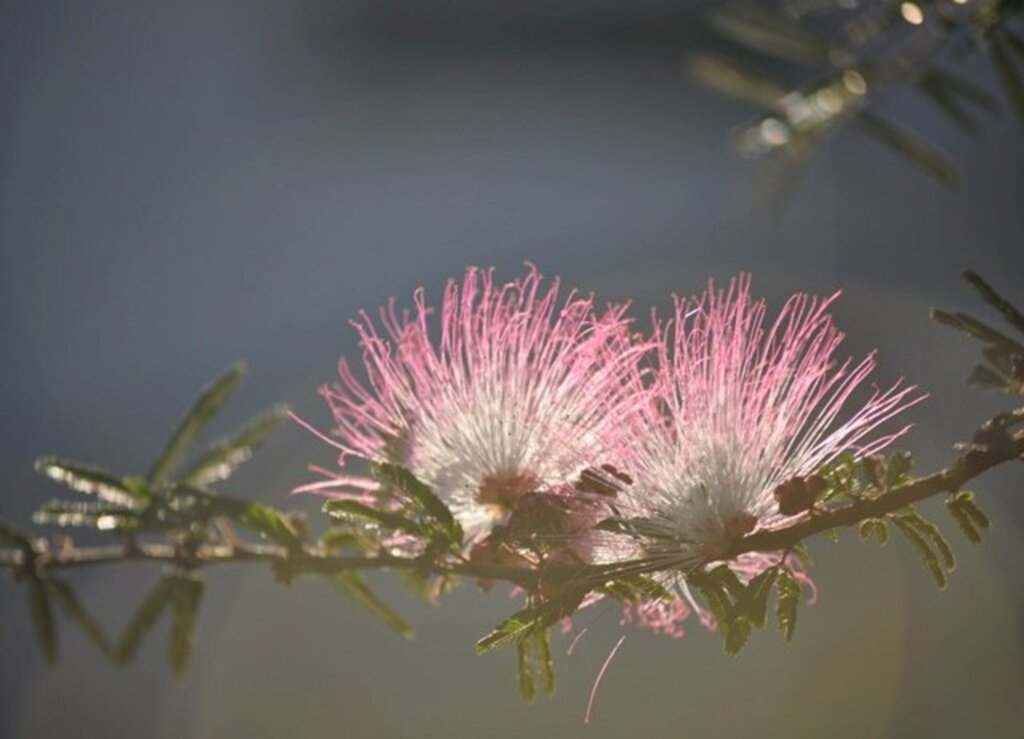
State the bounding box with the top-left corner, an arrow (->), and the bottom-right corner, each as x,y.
0,0 -> 1024,739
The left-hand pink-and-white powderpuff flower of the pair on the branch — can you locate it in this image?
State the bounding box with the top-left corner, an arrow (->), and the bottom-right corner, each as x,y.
301,266 -> 647,540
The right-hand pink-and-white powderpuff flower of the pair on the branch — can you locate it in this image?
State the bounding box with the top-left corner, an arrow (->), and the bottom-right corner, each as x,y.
623,275 -> 924,579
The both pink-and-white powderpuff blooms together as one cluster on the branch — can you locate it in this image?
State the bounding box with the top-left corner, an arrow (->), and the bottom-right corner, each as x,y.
302,267 -> 922,636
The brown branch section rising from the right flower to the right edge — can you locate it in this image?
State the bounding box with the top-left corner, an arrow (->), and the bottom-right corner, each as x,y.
729,431 -> 1024,558
